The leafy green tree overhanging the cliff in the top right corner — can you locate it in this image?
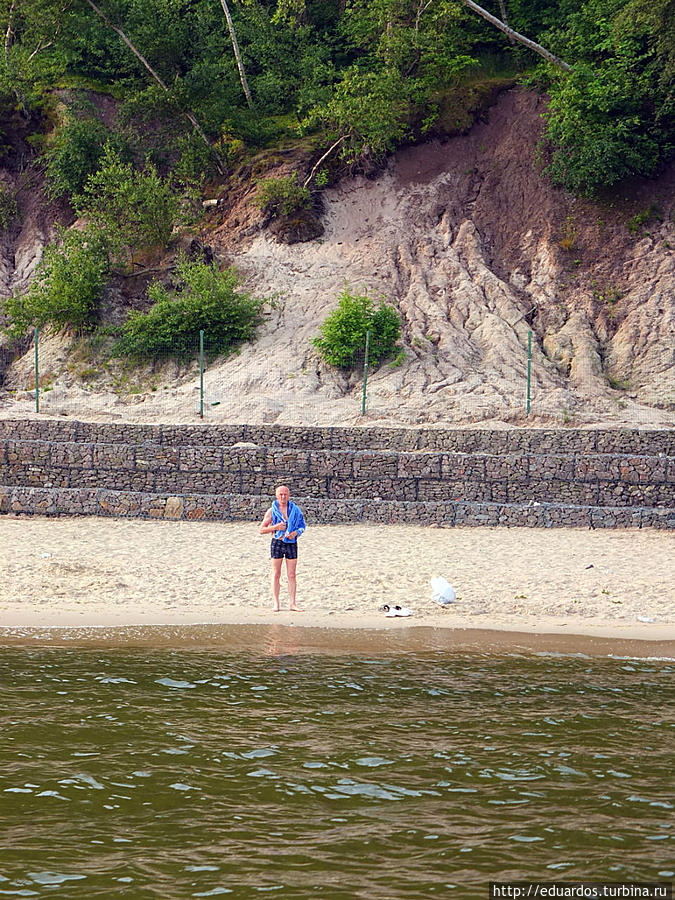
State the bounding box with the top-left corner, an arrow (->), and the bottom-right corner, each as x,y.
546,0 -> 675,194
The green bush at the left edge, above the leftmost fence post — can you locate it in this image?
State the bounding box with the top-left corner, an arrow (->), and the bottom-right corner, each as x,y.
3,228 -> 109,337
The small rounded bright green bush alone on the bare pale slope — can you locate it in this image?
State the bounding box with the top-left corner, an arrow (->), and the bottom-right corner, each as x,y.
312,290 -> 401,369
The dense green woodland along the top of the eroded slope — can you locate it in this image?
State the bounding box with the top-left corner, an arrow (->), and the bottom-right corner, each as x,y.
0,0 -> 675,196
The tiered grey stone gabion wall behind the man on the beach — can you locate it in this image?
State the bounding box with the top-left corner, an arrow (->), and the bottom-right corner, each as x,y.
0,420 -> 675,528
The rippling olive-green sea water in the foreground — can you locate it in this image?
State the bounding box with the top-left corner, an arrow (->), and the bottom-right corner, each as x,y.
0,646 -> 675,900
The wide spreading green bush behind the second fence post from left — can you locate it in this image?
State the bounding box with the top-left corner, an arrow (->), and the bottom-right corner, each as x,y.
114,260 -> 264,359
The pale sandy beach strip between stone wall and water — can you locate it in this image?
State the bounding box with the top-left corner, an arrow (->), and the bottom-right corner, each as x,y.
0,516 -> 675,655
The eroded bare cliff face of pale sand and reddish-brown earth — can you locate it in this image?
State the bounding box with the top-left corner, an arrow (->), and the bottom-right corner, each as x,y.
3,89 -> 675,425
